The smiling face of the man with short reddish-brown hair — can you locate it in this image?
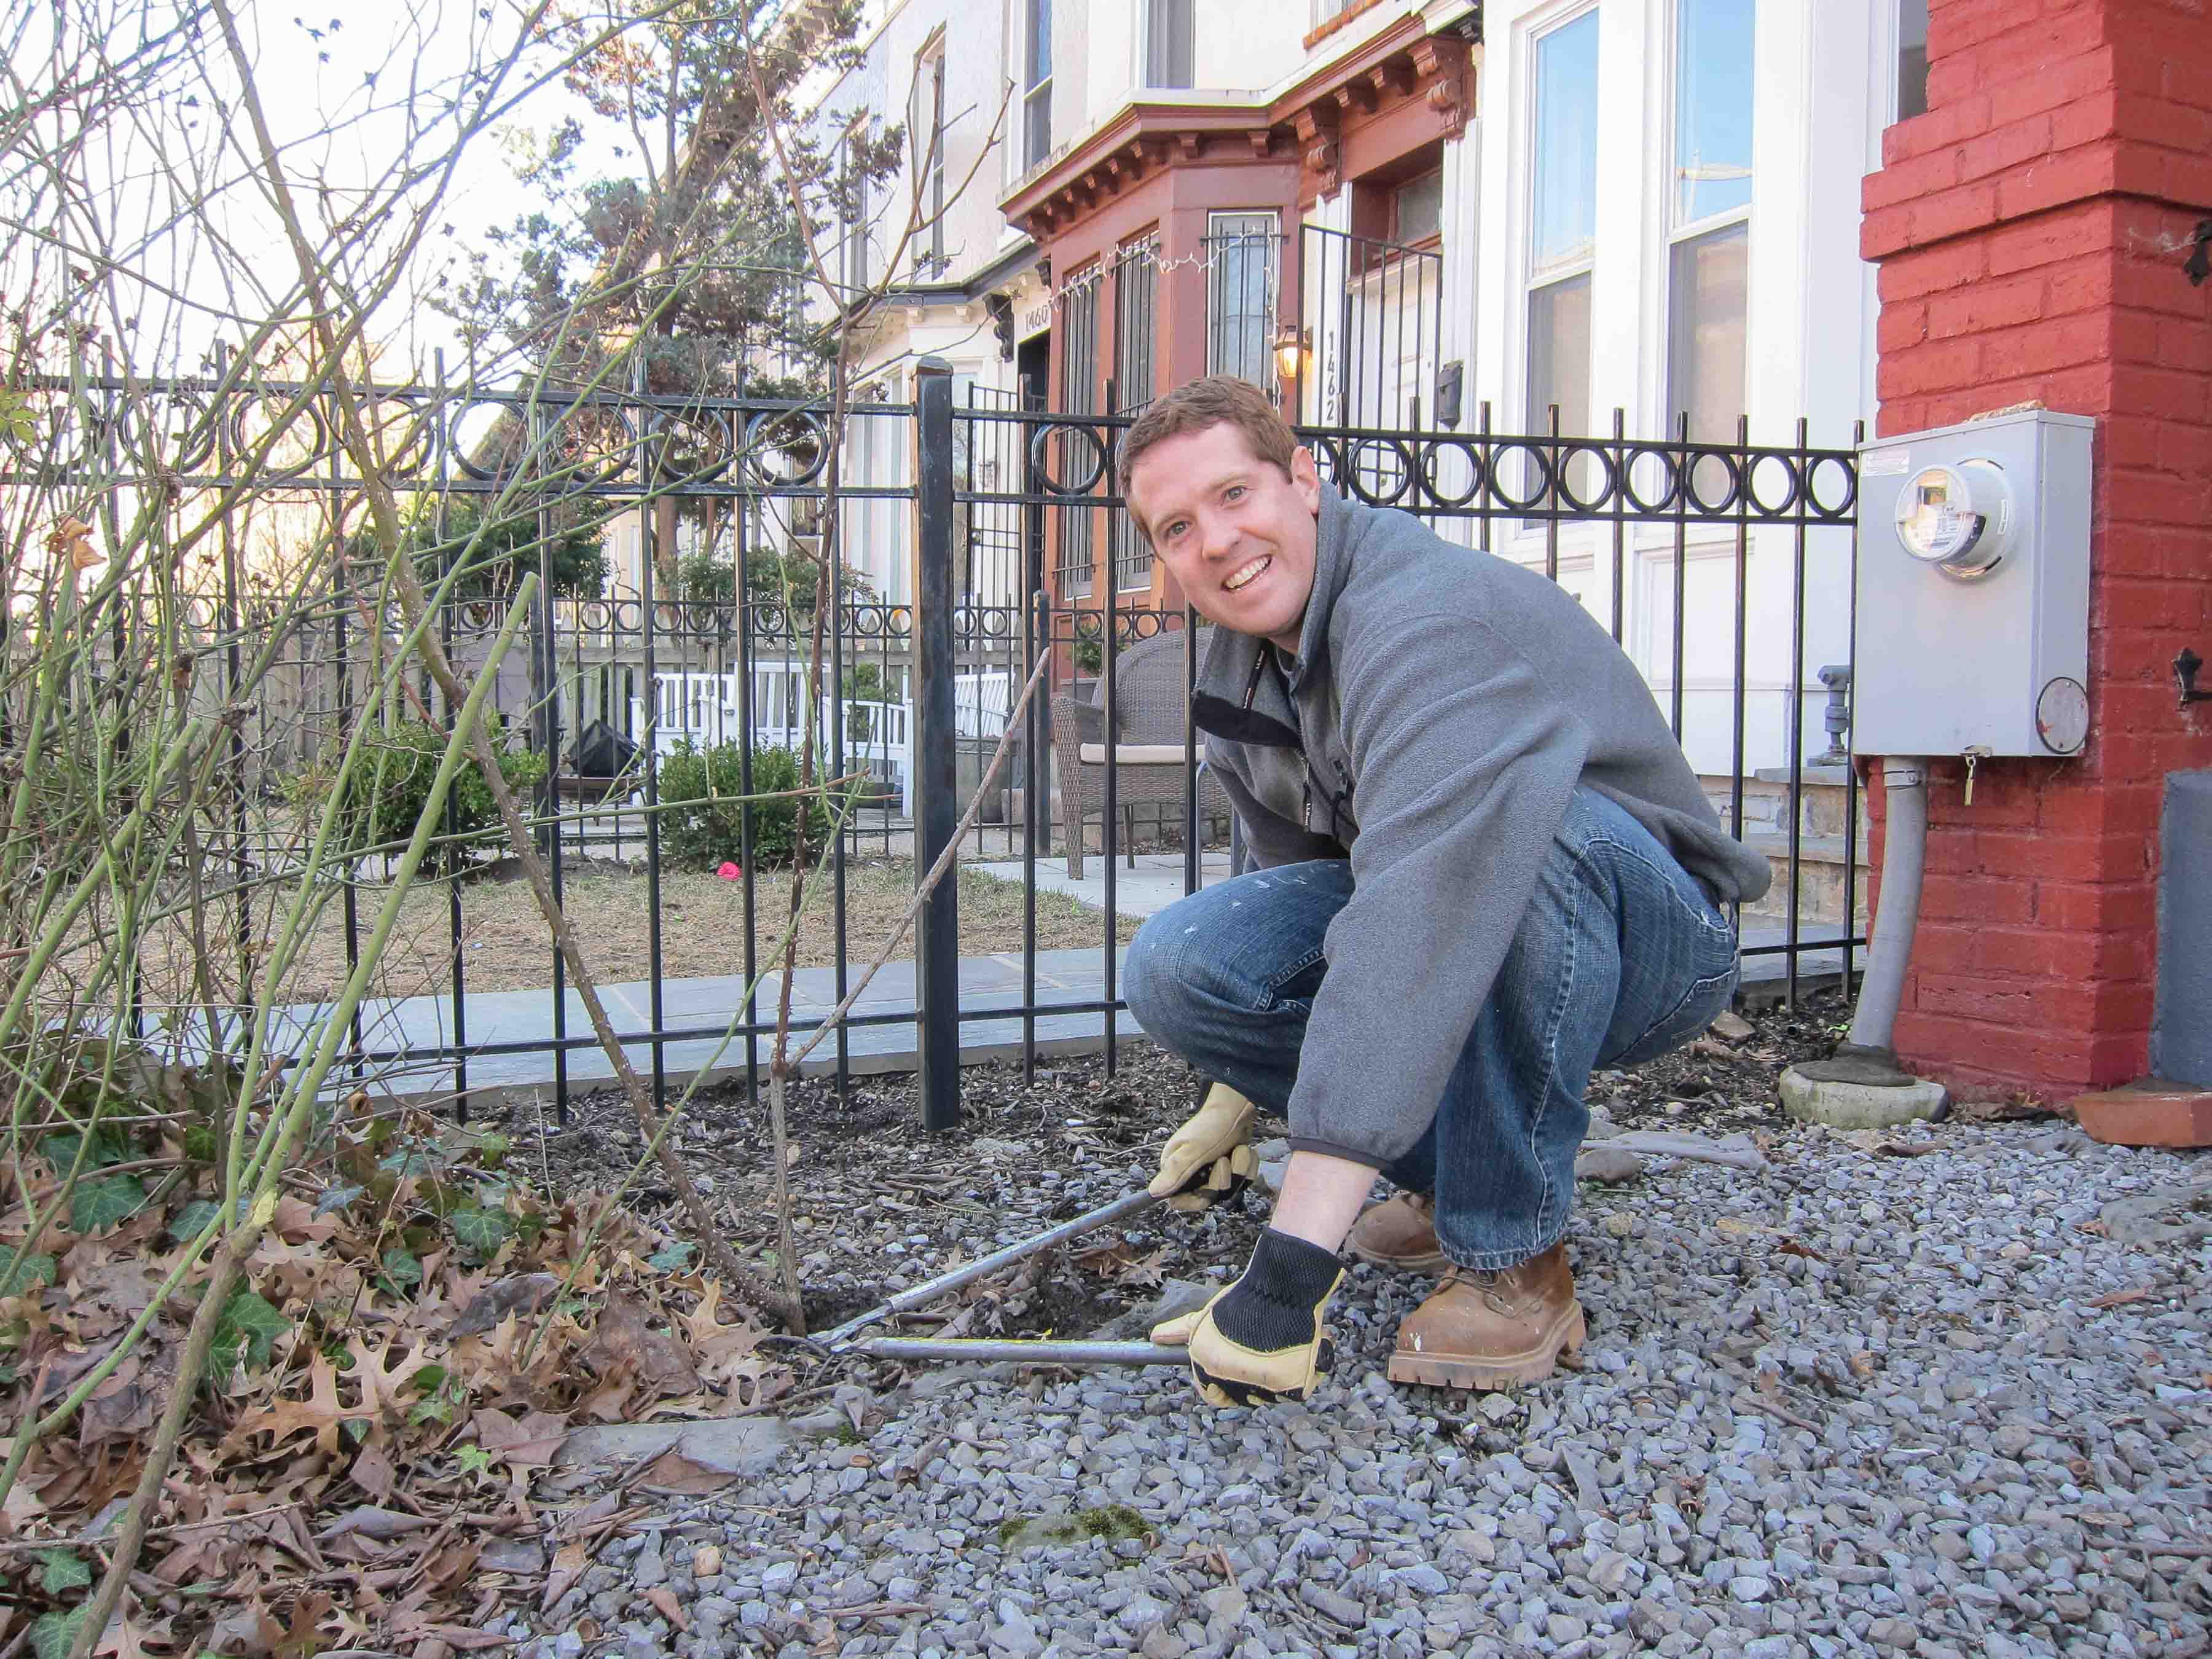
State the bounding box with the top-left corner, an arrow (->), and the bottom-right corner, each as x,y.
1128,423 -> 1320,650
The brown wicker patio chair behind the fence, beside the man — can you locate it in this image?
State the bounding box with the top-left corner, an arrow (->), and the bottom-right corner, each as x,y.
1053,628 -> 1230,880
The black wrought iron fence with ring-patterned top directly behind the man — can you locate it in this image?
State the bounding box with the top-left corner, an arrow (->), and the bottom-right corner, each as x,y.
0,369 -> 1861,1124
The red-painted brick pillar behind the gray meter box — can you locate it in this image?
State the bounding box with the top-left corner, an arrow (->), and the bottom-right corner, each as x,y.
1858,0 -> 2212,1095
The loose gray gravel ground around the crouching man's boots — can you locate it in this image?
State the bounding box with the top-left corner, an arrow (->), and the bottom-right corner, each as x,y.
511,1013 -> 2212,1659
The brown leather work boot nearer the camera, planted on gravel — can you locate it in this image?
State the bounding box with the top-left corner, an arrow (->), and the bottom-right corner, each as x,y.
1389,1245 -> 1584,1389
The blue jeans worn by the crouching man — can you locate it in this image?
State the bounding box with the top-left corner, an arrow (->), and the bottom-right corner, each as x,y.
1124,790 -> 1736,1269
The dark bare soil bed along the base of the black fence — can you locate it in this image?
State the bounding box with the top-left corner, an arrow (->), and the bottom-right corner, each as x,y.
506,991 -> 1847,1371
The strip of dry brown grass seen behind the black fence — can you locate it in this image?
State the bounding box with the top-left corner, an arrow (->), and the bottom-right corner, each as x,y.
73,860 -> 1139,1004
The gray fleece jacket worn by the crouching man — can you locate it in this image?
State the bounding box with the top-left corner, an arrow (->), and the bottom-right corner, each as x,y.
1194,487 -> 1770,1168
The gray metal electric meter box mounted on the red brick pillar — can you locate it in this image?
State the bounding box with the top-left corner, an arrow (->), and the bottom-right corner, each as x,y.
1851,409 -> 2097,759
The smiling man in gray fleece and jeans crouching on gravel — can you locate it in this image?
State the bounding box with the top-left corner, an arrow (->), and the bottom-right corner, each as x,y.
1120,376 -> 1767,1405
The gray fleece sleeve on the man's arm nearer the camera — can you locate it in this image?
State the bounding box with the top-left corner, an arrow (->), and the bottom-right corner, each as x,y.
1290,615 -> 1590,1168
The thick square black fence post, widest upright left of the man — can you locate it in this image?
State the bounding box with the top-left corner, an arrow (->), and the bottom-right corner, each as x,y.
907,356 -> 960,1131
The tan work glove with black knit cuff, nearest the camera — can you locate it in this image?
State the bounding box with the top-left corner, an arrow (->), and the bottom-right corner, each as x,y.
1153,1228 -> 1345,1405
